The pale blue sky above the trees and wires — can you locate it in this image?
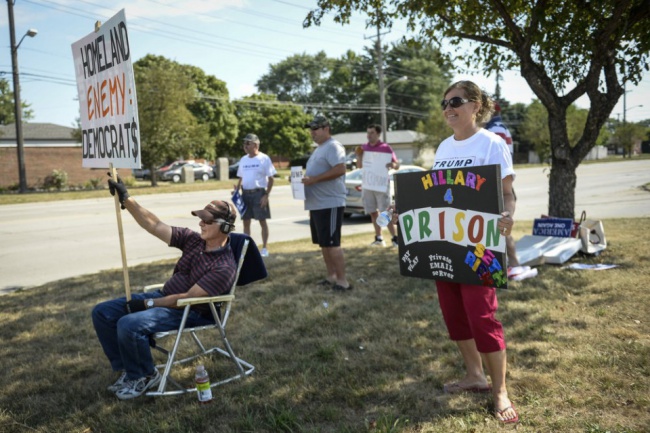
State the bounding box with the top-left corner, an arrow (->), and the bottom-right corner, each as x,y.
0,0 -> 650,126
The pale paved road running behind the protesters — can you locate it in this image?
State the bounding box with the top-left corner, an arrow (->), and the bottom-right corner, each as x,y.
0,160 -> 650,294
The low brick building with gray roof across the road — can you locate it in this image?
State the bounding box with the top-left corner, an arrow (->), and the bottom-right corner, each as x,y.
0,122 -> 106,189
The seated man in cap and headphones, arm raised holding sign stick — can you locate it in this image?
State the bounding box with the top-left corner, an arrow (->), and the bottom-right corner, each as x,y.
92,175 -> 237,400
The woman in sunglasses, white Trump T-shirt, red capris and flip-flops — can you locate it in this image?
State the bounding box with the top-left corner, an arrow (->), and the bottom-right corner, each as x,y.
433,81 -> 519,423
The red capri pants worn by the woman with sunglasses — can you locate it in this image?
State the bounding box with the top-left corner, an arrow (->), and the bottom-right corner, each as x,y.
436,281 -> 506,353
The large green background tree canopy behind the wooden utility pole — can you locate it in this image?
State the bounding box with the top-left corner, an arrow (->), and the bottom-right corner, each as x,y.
257,43 -> 451,132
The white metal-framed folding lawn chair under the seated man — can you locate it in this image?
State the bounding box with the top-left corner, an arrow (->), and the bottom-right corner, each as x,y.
144,233 -> 267,396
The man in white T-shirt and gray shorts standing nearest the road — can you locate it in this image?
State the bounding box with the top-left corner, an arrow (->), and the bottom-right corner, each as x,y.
235,134 -> 277,257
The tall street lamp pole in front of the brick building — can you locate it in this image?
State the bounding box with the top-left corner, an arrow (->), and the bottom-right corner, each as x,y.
7,0 -> 38,193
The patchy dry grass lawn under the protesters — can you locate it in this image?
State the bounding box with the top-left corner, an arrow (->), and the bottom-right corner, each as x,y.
0,218 -> 650,433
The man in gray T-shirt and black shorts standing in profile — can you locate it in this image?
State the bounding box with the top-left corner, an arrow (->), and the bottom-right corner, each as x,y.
302,116 -> 352,291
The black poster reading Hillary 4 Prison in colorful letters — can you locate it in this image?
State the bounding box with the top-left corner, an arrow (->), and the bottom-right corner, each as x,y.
395,165 -> 508,288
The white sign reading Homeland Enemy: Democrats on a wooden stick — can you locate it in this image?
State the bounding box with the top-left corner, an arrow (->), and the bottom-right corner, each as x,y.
72,9 -> 141,168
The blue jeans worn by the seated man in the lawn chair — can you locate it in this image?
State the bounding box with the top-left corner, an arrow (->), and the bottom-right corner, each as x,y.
92,291 -> 214,380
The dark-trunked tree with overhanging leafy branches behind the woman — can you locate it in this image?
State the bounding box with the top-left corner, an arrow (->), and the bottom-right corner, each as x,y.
305,0 -> 650,218
